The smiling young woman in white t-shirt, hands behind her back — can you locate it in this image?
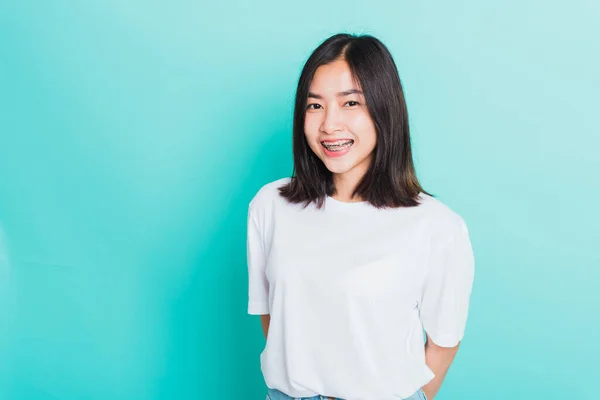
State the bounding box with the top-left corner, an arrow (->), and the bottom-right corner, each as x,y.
247,34 -> 474,400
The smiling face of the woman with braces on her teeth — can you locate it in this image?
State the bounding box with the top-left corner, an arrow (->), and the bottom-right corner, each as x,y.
304,60 -> 377,180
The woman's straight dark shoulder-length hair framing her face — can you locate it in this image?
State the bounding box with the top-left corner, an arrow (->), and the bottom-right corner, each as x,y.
279,33 -> 433,209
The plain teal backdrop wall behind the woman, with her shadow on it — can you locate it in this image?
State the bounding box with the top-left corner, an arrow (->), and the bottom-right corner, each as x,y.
0,0 -> 600,400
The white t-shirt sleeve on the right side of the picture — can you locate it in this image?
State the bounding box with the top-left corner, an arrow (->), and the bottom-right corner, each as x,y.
419,219 -> 474,347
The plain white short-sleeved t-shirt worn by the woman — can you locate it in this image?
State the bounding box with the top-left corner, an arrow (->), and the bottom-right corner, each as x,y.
247,178 -> 474,400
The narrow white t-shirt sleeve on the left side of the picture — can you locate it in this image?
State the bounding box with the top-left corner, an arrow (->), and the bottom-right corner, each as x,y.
246,209 -> 269,315
